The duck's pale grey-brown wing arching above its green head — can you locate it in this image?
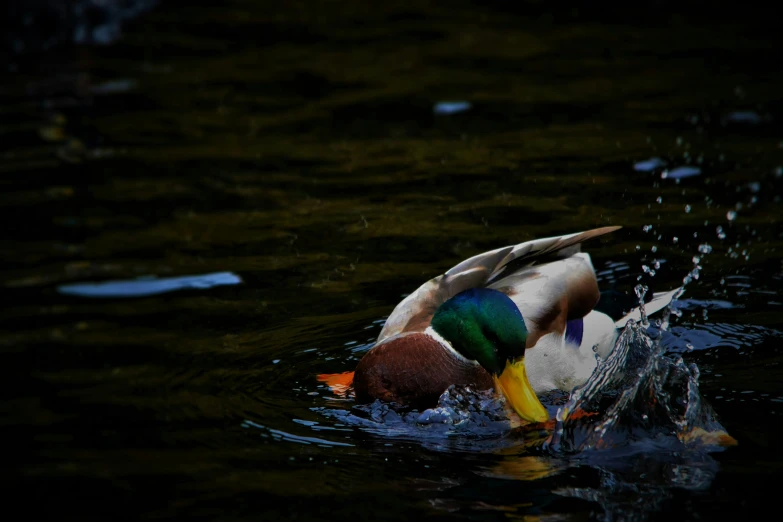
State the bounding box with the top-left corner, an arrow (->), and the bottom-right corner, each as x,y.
378,227 -> 621,342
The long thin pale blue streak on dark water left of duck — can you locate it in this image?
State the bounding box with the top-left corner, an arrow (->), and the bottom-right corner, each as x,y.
57,272 -> 242,298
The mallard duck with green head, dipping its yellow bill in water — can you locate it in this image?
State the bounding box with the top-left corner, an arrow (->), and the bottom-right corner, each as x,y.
319,226 -> 680,423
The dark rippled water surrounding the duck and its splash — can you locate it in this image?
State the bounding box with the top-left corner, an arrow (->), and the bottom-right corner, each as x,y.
0,1 -> 783,521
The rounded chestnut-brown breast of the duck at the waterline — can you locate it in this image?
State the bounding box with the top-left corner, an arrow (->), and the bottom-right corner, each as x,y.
354,333 -> 493,409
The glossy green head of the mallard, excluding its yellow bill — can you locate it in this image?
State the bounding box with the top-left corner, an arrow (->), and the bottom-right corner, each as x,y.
432,288 -> 528,375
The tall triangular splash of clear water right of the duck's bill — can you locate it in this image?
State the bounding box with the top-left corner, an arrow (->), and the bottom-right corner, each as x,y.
545,310 -> 736,455
